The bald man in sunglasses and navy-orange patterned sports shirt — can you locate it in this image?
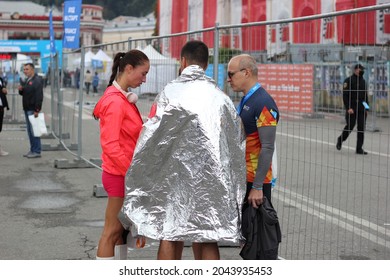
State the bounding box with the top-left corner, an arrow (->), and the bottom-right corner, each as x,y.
227,54 -> 279,208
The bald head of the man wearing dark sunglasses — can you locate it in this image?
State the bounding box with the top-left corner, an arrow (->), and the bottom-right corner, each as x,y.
227,54 -> 258,93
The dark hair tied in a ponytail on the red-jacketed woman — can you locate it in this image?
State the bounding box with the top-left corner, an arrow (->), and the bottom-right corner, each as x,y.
107,50 -> 149,87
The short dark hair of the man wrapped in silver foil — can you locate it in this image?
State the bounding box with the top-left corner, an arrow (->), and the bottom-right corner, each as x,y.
180,40 -> 209,69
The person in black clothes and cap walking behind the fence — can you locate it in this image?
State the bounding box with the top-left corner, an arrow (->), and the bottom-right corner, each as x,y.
336,64 -> 370,155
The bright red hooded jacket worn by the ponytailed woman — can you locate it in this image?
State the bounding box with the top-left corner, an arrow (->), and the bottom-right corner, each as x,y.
93,86 -> 143,176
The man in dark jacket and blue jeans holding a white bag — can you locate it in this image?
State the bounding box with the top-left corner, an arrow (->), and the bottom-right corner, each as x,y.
18,63 -> 43,158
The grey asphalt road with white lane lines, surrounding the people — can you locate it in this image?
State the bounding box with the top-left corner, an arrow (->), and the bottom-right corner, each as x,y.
0,89 -> 390,260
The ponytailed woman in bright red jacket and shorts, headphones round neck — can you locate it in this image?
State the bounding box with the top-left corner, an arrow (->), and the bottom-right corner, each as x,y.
93,50 -> 150,259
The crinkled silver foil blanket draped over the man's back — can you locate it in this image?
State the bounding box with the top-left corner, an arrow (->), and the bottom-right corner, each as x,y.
120,66 -> 246,244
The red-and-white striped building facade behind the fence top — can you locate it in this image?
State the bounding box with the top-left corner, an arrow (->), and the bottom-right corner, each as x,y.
158,0 -> 390,56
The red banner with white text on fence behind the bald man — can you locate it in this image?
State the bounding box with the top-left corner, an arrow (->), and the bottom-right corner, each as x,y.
258,64 -> 314,113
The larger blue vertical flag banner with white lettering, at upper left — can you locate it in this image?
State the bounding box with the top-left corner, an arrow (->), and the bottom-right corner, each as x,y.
63,0 -> 82,49
